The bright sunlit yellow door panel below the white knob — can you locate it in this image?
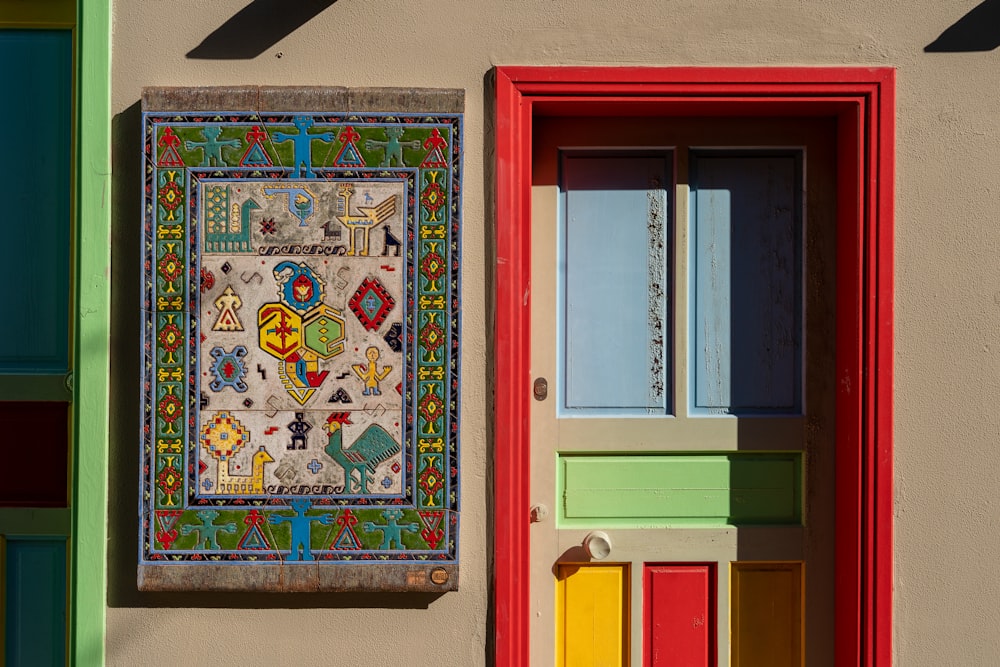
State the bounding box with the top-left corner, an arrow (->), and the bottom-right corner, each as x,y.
556,563 -> 629,667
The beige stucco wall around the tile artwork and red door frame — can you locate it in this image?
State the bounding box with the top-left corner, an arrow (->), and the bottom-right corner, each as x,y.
107,0 -> 1000,667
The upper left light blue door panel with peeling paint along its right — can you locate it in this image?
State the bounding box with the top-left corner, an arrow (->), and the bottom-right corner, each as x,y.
557,154 -> 670,414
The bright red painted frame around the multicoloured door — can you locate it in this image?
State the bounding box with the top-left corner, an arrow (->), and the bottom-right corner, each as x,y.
493,67 -> 895,667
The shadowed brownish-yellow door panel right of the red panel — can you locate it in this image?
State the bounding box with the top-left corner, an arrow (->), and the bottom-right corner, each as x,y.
730,561 -> 804,667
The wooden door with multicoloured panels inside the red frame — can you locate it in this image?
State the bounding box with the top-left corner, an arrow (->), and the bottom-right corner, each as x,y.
529,118 -> 836,667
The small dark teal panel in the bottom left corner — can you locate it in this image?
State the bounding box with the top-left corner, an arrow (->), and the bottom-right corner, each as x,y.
4,537 -> 66,667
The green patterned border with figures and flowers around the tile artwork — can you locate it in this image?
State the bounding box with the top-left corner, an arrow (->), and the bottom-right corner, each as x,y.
139,112 -> 462,566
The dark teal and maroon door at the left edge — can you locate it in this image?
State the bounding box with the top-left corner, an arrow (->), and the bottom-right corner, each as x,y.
0,2 -> 75,667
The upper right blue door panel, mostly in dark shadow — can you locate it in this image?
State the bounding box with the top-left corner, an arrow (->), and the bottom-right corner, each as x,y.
690,152 -> 802,413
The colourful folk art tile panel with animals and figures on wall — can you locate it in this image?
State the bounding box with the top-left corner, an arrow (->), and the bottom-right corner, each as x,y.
139,98 -> 462,590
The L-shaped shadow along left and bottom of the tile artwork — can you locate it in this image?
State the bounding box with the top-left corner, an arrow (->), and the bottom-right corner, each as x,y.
108,100 -> 443,612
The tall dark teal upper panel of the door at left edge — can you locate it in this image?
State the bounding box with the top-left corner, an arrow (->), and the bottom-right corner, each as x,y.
0,30 -> 73,374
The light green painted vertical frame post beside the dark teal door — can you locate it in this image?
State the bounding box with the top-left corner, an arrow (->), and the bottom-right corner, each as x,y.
69,0 -> 111,665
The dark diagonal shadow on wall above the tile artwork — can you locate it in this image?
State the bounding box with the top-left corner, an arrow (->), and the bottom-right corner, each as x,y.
187,0 -> 337,60
